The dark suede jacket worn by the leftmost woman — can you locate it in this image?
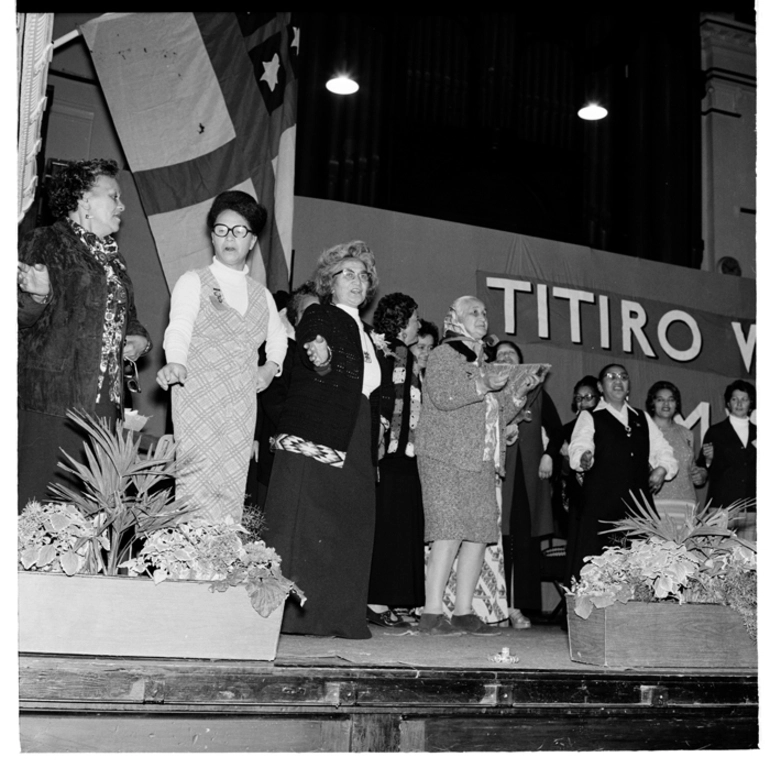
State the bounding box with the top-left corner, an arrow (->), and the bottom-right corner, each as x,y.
17,220 -> 150,416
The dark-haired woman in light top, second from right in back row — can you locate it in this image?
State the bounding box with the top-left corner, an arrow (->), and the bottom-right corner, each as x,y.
645,381 -> 706,508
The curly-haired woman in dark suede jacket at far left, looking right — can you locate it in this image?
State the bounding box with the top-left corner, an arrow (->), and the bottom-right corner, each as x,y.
17,160 -> 151,508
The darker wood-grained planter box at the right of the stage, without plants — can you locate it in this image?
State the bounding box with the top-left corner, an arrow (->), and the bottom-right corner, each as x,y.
567,595 -> 757,669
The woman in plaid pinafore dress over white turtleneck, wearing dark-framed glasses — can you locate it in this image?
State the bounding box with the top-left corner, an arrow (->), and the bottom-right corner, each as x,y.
157,191 -> 286,522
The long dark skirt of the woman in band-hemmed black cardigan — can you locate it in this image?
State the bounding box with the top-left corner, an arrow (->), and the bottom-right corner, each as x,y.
264,395 -> 375,639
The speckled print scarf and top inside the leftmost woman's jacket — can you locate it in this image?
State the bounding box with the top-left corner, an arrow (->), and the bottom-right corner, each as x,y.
65,218 -> 128,407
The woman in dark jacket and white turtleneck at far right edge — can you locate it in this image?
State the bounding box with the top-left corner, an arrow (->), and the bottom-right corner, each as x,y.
698,380 -> 757,537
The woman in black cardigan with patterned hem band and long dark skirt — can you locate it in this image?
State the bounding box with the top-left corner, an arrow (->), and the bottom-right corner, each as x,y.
265,240 -> 392,639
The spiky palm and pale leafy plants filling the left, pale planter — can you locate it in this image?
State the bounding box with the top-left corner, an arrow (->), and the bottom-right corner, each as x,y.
18,412 -> 305,617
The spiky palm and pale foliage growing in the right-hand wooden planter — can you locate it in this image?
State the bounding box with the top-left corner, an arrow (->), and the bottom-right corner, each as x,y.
567,499 -> 757,637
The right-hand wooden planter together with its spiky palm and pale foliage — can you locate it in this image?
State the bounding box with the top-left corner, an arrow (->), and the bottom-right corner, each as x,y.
567,499 -> 757,668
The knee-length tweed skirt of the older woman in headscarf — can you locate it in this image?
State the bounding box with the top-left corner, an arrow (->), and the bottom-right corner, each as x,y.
417,456 -> 500,544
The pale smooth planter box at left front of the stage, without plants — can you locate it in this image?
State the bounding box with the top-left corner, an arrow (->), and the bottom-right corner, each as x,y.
18,571 -> 283,661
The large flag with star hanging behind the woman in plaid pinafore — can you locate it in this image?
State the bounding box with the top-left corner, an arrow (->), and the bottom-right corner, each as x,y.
80,12 -> 299,292
